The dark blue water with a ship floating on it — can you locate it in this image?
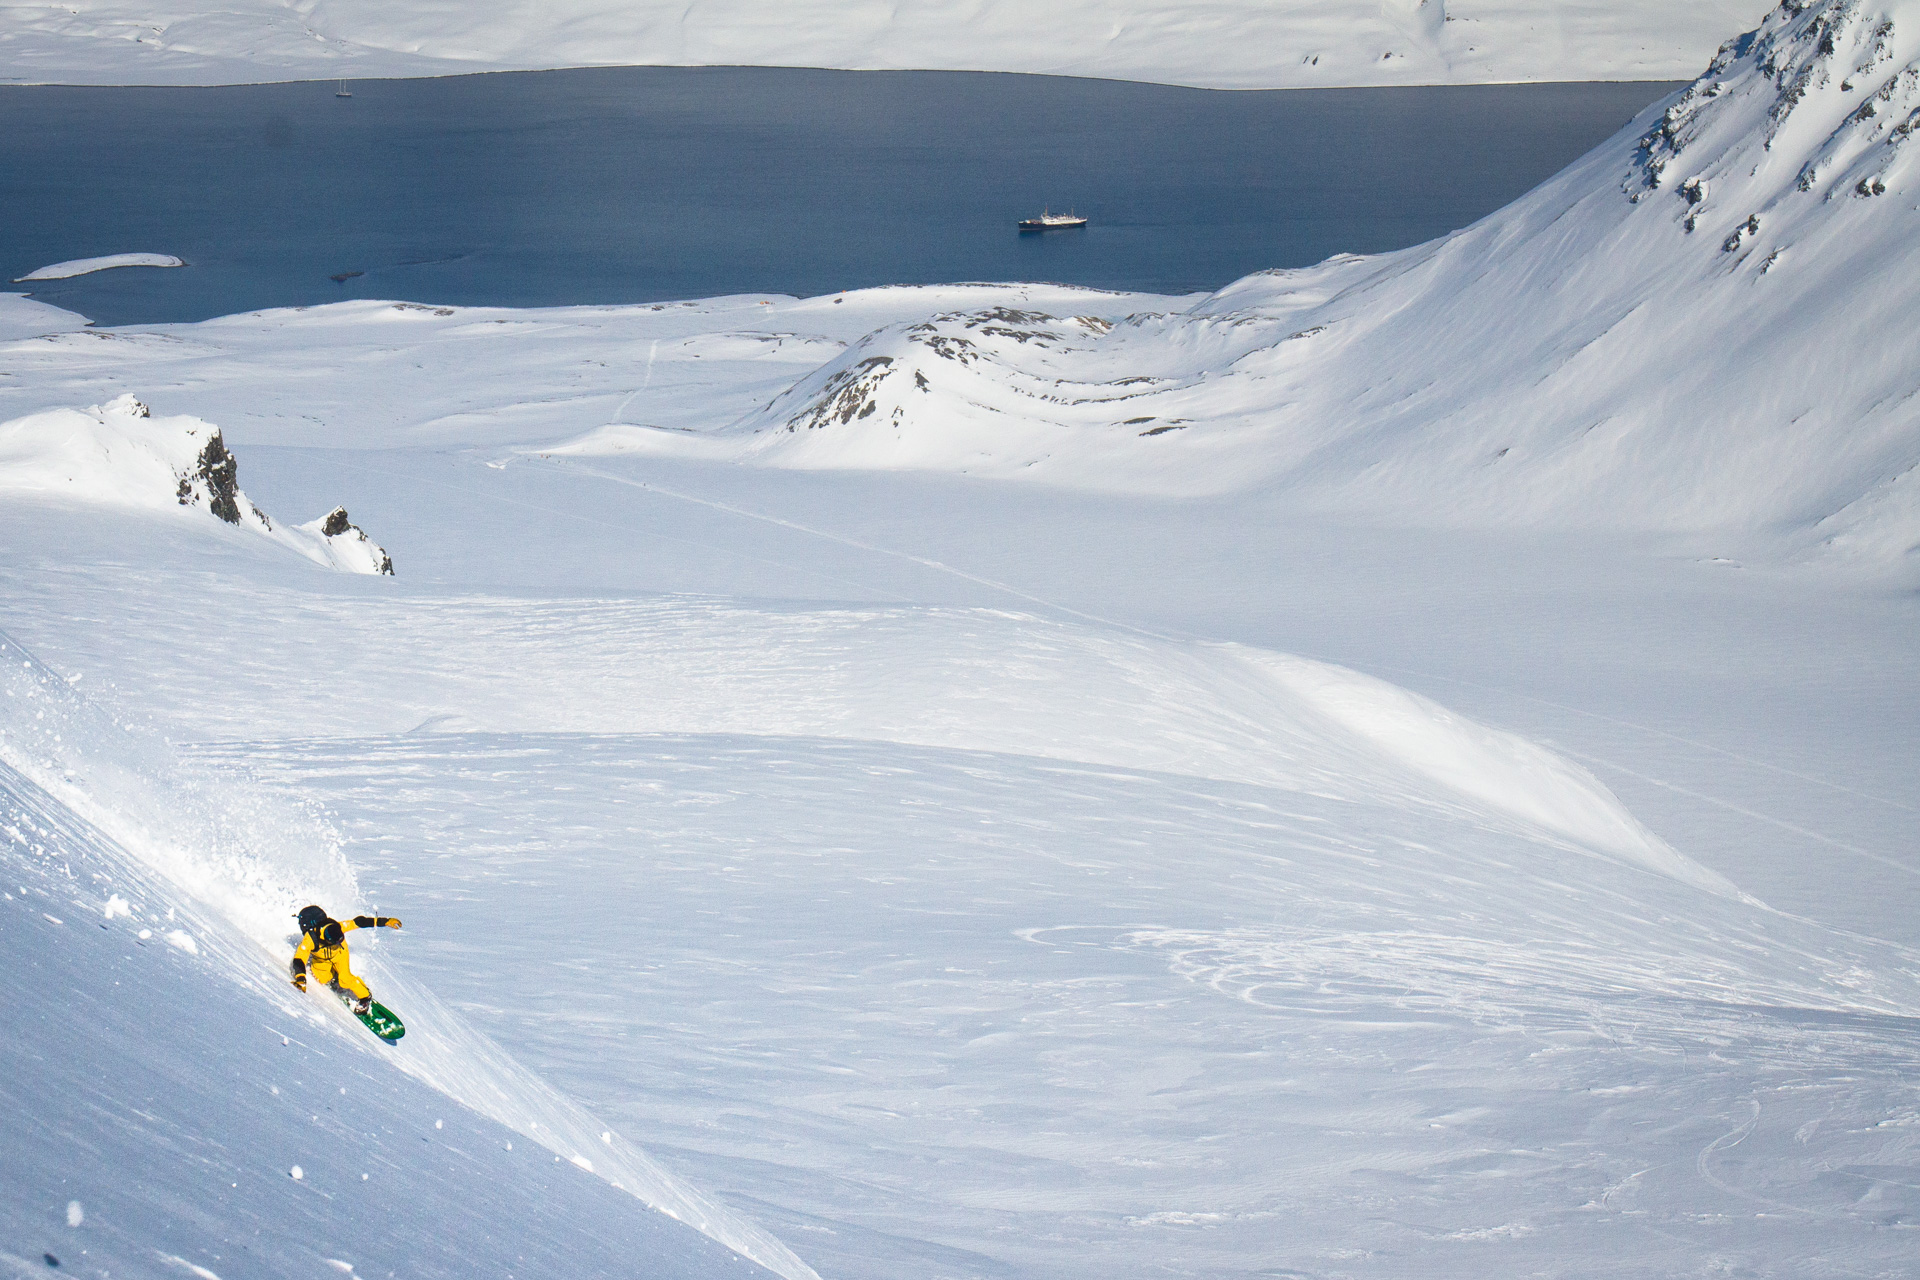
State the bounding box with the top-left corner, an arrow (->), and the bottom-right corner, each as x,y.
0,67 -> 1674,324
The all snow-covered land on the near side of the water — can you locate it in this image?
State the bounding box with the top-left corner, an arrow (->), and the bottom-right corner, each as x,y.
0,0 -> 1920,1280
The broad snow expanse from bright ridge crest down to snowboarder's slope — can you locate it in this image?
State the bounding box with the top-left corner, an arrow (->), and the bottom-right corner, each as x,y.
0,487 -> 1920,1280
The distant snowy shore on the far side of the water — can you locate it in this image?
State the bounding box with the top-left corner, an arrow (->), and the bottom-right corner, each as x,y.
0,0 -> 1766,88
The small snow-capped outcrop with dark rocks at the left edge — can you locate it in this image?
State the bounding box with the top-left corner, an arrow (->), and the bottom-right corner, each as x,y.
0,395 -> 394,574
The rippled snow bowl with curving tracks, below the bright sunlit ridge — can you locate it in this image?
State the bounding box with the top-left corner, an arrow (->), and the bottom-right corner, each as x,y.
187,733 -> 1920,1276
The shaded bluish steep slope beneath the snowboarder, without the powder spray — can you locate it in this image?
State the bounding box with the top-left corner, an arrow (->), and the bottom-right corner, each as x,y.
0,790 -> 768,1278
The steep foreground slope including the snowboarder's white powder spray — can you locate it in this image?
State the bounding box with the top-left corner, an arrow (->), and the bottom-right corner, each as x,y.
0,637 -> 810,1280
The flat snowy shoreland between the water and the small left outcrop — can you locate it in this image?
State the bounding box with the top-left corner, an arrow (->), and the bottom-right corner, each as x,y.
0,284 -> 1198,453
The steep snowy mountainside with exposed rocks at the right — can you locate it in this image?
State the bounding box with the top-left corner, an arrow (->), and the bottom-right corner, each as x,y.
702,0 -> 1920,562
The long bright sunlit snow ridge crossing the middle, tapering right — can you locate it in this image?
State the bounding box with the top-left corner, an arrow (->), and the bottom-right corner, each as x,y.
0,576 -> 1738,896
